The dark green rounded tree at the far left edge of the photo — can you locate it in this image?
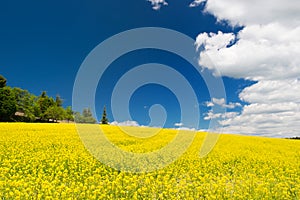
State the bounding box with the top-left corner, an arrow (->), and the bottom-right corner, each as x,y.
0,87 -> 17,121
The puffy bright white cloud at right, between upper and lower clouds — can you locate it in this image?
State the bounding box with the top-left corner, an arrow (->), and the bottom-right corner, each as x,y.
196,24 -> 300,81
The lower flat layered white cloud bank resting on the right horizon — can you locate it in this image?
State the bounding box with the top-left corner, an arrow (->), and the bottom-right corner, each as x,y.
220,80 -> 300,137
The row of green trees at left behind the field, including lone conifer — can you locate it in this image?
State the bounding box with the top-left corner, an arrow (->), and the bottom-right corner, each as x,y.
0,75 -> 108,124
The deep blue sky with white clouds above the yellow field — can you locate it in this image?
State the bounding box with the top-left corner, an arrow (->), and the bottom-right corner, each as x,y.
0,0 -> 300,137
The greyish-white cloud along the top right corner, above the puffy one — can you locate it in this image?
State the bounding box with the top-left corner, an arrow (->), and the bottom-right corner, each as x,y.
190,0 -> 300,26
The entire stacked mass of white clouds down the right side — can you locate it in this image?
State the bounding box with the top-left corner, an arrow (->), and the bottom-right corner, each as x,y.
190,0 -> 300,137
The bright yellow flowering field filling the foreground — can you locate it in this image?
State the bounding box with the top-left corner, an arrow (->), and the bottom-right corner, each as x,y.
0,123 -> 300,199
